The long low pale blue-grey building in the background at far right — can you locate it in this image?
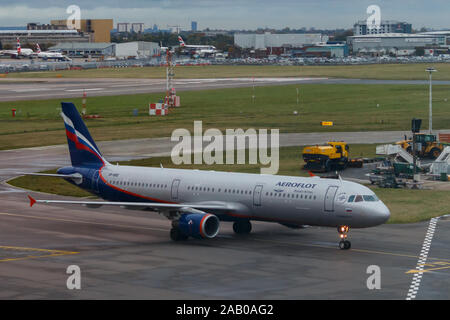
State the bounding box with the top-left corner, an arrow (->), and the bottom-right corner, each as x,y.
347,33 -> 447,55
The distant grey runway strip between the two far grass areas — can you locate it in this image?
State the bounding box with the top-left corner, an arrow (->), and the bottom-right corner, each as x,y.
0,77 -> 450,101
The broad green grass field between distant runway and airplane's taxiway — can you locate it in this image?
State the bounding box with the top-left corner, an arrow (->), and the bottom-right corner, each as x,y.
0,84 -> 450,150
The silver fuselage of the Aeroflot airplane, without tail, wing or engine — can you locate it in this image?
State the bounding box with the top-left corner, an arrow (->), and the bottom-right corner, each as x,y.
100,164 -> 390,228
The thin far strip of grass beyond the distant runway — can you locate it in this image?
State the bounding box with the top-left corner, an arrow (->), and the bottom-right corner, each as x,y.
7,63 -> 450,80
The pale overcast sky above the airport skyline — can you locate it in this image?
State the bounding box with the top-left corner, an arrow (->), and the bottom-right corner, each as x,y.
0,0 -> 450,30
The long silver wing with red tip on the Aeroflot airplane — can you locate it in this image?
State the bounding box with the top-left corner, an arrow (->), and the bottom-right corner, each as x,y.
28,195 -> 242,213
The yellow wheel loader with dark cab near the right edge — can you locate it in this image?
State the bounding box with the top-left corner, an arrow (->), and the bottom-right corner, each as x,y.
396,133 -> 444,159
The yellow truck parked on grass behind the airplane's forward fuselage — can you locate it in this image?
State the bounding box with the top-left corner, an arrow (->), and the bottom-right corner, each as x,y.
303,141 -> 350,172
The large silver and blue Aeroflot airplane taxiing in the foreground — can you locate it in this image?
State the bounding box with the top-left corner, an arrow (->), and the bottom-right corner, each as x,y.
28,102 -> 390,250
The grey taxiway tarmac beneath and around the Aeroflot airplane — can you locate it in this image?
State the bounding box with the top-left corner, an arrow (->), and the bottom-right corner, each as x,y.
0,132 -> 450,299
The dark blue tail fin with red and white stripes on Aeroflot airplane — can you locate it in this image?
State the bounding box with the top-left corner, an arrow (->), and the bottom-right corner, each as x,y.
61,102 -> 107,168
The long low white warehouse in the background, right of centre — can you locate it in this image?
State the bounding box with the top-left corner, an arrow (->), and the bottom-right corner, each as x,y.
234,32 -> 328,50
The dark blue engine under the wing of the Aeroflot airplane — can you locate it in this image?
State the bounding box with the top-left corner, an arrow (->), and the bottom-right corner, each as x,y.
177,213 -> 220,239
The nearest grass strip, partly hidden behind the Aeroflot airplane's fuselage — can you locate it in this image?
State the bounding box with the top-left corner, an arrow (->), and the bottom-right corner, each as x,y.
8,144 -> 450,223
